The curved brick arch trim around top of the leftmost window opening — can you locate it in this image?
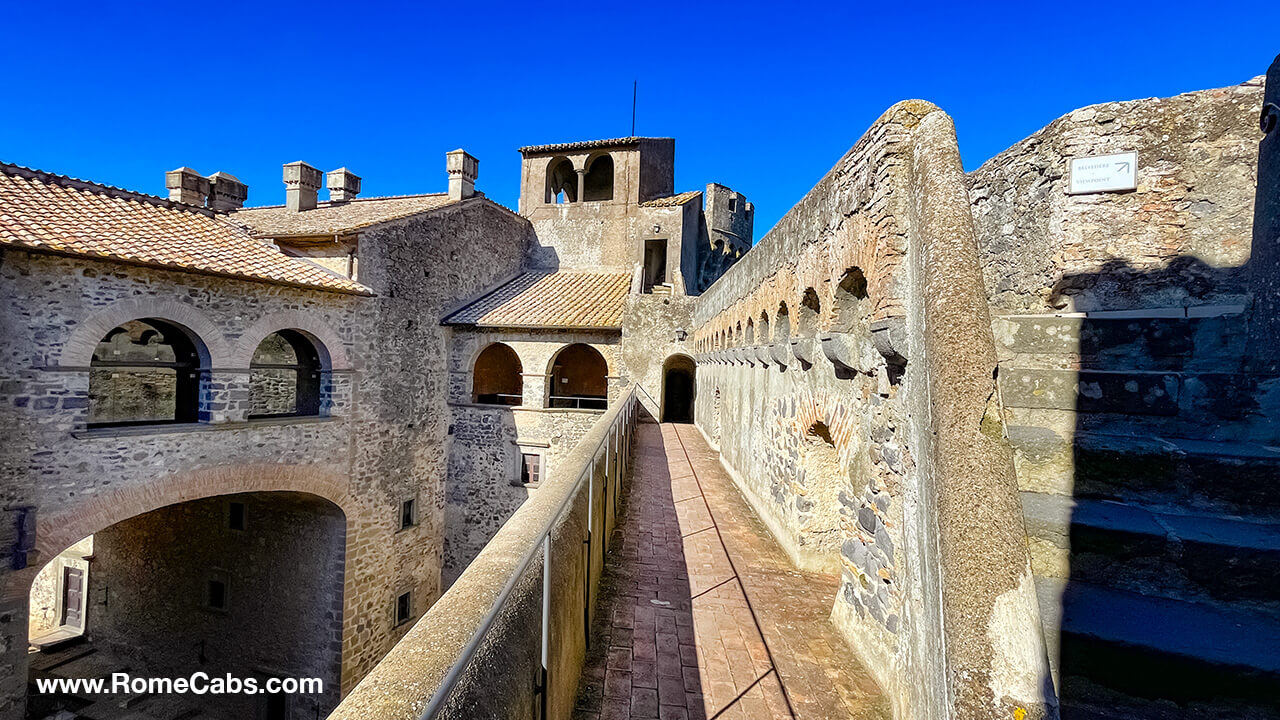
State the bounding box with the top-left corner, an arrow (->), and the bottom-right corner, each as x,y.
58,297 -> 230,368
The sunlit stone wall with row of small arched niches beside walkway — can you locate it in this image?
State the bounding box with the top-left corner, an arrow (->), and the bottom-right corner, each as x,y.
692,101 -> 1052,717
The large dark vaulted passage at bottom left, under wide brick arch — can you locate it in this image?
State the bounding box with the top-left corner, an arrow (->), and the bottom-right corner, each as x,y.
27,492 -> 346,720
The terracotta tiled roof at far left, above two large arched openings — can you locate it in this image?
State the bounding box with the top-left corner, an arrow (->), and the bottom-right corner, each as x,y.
0,163 -> 371,295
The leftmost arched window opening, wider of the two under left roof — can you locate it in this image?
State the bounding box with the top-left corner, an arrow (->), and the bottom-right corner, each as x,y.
88,318 -> 205,428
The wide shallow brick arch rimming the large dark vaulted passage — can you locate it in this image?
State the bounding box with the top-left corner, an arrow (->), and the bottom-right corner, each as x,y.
32,464 -> 356,558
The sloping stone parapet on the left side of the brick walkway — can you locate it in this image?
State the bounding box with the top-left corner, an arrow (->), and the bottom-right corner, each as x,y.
329,388 -> 637,720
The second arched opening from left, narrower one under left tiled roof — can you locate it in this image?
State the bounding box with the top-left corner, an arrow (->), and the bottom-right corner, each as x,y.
248,329 -> 323,418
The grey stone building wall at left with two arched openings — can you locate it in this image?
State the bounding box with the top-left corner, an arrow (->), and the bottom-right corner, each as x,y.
0,199 -> 530,710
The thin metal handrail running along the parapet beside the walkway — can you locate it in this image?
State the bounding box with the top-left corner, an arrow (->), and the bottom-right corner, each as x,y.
419,386 -> 636,720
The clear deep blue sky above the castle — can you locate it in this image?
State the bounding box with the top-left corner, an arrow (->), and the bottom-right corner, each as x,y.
0,0 -> 1280,238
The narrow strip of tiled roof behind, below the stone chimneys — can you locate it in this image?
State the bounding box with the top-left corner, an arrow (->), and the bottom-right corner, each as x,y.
228,192 -> 452,237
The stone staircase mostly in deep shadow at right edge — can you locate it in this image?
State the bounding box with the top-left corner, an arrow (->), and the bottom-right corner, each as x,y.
995,306 -> 1280,720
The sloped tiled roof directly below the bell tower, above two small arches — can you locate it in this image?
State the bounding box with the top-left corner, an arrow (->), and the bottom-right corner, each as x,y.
444,270 -> 631,328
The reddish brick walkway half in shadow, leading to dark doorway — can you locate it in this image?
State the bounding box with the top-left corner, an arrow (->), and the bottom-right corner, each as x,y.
575,424 -> 890,720
